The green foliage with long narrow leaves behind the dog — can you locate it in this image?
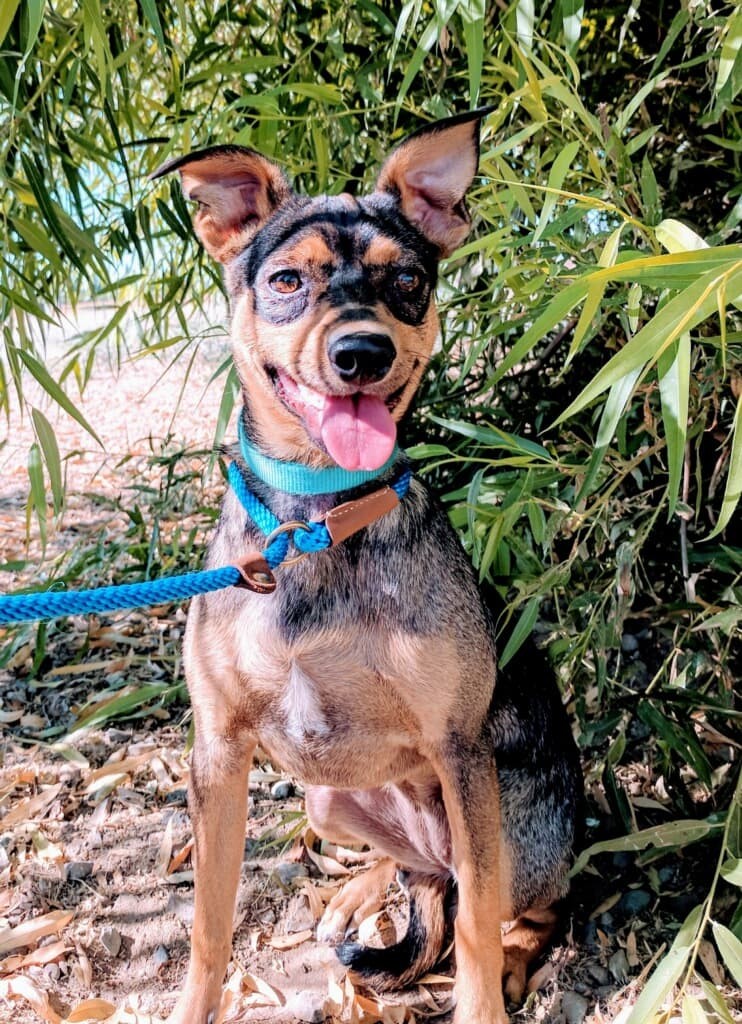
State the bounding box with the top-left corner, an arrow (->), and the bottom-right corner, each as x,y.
0,0 -> 742,1021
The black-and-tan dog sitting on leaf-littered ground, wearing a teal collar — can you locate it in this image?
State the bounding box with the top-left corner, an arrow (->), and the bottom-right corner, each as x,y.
154,110 -> 581,1024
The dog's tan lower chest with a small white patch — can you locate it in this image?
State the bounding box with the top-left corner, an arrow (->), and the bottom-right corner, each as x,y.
230,608 -> 457,786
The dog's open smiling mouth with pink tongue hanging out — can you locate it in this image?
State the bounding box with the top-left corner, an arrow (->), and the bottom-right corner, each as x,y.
266,367 -> 406,470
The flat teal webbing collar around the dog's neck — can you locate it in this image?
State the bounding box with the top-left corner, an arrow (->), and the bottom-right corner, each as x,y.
237,414 -> 401,495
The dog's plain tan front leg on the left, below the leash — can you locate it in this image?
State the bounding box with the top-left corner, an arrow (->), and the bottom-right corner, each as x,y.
168,721 -> 255,1024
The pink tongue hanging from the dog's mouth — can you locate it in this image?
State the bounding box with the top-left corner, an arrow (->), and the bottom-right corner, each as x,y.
320,394 -> 397,469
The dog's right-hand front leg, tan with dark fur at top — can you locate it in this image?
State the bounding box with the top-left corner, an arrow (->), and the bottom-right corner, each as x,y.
436,736 -> 508,1024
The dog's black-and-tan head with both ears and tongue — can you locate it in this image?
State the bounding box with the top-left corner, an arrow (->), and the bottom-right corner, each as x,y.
154,111 -> 487,469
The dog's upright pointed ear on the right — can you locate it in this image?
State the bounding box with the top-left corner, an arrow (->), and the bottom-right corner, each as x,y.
377,106 -> 494,256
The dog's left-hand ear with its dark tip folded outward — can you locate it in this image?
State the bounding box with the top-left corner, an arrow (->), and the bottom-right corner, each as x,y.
150,145 -> 292,263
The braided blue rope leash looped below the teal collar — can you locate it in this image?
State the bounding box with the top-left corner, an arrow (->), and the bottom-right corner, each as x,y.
0,463 -> 412,624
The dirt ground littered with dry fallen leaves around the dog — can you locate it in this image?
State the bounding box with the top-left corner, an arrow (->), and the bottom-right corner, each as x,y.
0,352 -> 742,1024
